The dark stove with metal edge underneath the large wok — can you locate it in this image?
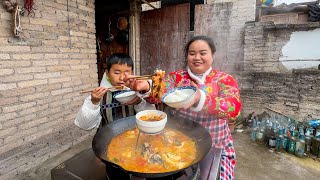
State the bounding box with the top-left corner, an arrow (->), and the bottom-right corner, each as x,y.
51,148 -> 221,180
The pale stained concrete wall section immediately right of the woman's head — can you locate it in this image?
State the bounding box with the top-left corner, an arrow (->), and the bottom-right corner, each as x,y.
194,0 -> 256,74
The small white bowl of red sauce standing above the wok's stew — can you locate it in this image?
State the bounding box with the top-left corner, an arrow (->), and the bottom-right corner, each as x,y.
136,110 -> 167,134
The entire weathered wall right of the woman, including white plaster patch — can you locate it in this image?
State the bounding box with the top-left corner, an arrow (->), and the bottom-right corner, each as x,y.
198,0 -> 320,120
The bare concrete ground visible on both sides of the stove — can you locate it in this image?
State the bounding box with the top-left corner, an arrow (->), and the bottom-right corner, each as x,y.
21,132 -> 320,180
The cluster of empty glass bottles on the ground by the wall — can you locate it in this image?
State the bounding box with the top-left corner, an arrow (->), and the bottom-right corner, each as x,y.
249,116 -> 320,157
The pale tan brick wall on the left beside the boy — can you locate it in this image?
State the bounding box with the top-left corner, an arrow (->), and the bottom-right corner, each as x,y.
0,0 -> 98,179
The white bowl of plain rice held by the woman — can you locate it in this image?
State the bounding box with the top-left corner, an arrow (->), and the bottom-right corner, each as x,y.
161,86 -> 197,109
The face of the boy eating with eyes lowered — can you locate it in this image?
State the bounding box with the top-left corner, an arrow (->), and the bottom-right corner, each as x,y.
106,64 -> 132,86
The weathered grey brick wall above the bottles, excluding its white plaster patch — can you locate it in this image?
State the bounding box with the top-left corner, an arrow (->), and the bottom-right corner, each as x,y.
240,22 -> 320,121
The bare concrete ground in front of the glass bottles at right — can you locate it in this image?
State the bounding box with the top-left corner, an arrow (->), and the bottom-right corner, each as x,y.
233,132 -> 320,180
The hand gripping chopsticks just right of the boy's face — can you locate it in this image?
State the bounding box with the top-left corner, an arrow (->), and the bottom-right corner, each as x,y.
123,74 -> 150,92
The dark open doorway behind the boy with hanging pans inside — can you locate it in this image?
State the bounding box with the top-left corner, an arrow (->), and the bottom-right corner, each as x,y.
95,0 -> 130,82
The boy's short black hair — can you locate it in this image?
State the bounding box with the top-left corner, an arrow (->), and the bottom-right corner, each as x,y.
106,53 -> 133,71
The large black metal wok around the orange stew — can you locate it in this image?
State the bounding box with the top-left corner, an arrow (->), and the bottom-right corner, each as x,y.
92,114 -> 212,178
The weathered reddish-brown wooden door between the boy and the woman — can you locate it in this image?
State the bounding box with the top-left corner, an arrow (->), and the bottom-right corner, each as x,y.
140,3 -> 190,74
